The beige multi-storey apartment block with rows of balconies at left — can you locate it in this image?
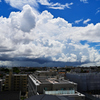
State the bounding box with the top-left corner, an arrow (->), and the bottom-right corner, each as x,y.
5,71 -> 27,93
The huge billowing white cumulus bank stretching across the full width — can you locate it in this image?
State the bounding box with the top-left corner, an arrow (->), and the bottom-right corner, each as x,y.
0,5 -> 100,64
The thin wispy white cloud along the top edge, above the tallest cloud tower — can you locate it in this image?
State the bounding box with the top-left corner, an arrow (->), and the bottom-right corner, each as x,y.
5,0 -> 73,9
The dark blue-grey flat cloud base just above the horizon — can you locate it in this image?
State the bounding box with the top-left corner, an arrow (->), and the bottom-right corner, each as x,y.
0,55 -> 89,67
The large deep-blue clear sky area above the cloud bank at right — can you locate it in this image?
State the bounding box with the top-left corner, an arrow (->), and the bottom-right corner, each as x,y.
39,0 -> 100,26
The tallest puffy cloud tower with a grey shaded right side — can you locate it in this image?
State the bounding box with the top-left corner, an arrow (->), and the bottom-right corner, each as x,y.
10,5 -> 35,32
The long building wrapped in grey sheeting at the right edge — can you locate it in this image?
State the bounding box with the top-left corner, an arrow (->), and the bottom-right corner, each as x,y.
66,73 -> 100,93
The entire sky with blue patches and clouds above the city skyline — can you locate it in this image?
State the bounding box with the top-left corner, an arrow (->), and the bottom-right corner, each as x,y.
0,0 -> 100,67
